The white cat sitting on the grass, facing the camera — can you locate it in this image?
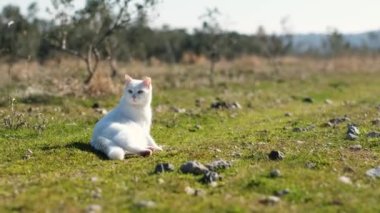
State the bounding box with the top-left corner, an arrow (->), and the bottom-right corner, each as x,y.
91,75 -> 162,160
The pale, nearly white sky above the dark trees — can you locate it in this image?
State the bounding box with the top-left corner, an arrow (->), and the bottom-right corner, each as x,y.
0,0 -> 380,33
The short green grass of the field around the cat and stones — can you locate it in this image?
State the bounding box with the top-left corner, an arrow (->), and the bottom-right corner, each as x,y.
0,62 -> 380,212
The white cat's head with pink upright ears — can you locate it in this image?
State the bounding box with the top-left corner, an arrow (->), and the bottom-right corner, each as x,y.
124,75 -> 152,106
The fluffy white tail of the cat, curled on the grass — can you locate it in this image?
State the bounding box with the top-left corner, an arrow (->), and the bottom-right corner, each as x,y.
91,137 -> 125,160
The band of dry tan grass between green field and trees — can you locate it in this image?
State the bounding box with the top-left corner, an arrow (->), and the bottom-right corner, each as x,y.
0,54 -> 380,96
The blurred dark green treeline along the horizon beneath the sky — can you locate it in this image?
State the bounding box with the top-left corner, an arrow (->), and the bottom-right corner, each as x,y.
0,1 -> 372,63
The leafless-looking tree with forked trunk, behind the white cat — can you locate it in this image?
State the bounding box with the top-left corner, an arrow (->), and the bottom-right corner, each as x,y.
45,0 -> 156,84
